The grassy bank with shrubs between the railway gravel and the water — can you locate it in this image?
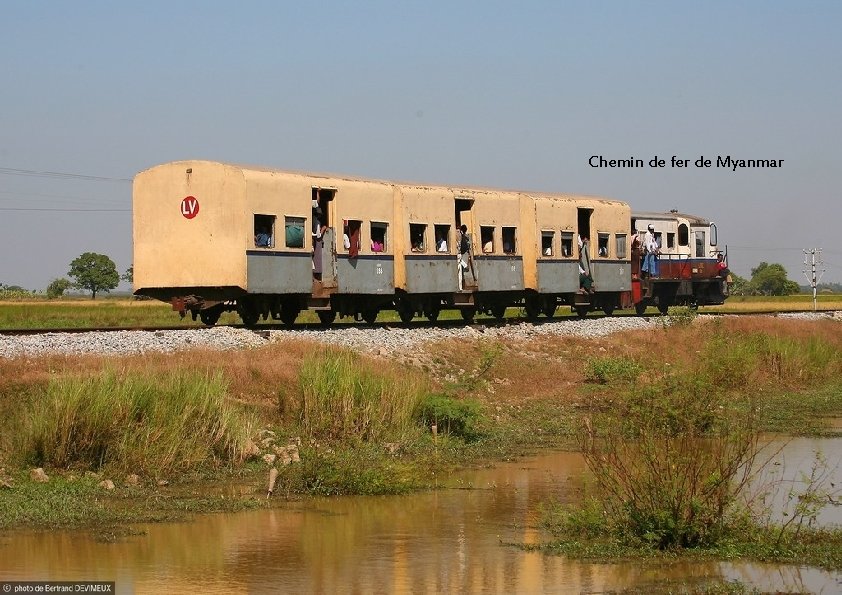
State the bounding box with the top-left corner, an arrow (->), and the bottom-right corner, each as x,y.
0,318 -> 842,568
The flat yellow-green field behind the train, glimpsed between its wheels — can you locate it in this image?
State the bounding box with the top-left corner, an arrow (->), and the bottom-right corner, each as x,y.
0,295 -> 842,330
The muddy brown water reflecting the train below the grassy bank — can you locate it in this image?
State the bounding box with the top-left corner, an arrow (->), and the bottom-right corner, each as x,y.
0,440 -> 842,594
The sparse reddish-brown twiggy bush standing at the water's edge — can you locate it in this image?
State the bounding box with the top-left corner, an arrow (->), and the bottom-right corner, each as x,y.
580,379 -> 759,549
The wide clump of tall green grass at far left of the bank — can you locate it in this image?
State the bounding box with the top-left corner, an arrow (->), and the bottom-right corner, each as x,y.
19,372 -> 253,472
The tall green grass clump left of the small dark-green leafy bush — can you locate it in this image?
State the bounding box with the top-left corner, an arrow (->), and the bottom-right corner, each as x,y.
299,350 -> 425,440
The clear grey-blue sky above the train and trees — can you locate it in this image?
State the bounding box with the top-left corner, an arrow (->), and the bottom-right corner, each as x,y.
0,0 -> 842,289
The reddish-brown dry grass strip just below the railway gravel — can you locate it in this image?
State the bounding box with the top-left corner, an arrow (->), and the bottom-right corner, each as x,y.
0,316 -> 842,450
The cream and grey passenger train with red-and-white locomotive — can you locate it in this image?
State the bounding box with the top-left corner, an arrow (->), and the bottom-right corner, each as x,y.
132,160 -> 728,327
